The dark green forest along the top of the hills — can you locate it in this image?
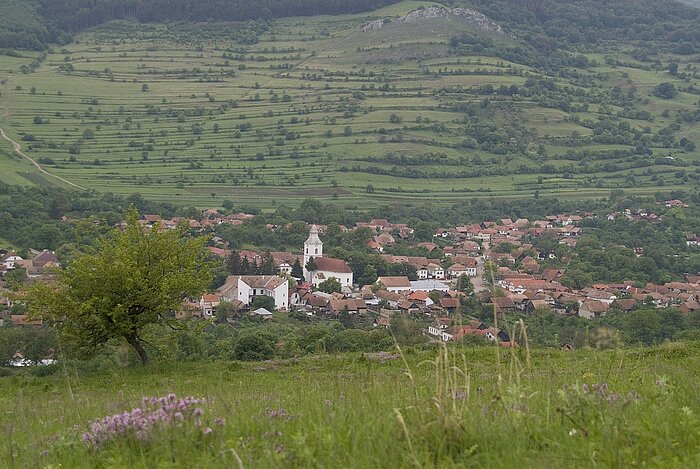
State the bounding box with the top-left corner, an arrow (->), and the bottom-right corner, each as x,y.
0,0 -> 700,50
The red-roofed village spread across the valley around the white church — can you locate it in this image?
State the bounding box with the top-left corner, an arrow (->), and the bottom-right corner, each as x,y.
0,200 -> 700,346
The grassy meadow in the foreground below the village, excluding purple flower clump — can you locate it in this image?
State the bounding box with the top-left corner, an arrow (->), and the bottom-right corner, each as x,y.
0,344 -> 700,468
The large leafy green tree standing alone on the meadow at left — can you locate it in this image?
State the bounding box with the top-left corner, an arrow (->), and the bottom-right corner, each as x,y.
30,210 -> 210,364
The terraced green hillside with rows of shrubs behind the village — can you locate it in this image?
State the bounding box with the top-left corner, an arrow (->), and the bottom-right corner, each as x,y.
0,1 -> 700,208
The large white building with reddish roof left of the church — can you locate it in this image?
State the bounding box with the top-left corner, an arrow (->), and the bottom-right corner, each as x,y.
219,275 -> 289,311
